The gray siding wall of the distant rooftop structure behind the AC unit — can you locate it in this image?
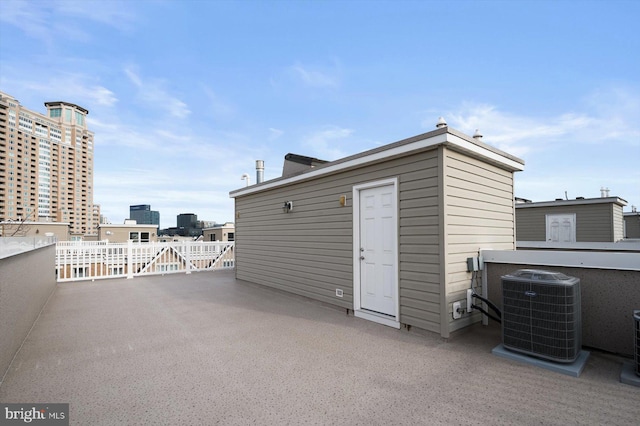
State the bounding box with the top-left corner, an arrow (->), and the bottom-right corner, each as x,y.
516,203 -> 622,242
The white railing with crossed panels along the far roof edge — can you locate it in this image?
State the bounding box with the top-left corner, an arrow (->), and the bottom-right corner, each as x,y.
56,241 -> 235,282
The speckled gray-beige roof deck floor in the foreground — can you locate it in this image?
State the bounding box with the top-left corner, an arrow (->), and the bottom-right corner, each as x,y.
0,271 -> 640,425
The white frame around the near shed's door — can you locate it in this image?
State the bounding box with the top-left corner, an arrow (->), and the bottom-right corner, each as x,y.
353,177 -> 400,328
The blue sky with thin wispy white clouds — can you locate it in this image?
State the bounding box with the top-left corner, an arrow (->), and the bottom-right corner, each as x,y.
0,0 -> 640,227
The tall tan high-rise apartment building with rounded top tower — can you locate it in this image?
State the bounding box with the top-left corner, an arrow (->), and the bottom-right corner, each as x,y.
0,92 -> 100,236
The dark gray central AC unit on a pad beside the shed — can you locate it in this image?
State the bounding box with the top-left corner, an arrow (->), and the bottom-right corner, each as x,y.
502,269 -> 582,363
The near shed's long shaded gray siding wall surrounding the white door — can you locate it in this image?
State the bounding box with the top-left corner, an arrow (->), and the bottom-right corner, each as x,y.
235,149 -> 440,332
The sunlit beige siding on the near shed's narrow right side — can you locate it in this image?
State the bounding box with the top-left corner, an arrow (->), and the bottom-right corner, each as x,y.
443,150 -> 515,332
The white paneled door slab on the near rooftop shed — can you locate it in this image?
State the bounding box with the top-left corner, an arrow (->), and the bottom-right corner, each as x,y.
359,185 -> 398,318
